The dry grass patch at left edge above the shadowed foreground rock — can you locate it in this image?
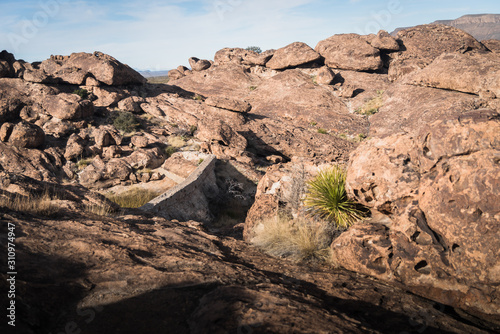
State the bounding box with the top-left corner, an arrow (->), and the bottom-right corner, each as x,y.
0,190 -> 60,216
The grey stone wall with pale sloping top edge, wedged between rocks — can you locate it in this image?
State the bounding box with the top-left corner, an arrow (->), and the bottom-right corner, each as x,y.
140,155 -> 219,223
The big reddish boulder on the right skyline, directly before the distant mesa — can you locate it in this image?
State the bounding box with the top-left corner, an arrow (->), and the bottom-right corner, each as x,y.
389,24 -> 487,80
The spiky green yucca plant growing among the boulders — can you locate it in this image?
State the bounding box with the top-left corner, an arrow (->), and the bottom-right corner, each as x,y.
304,166 -> 363,229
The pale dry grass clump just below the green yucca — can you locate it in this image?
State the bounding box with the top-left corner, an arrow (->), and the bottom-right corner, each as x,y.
252,215 -> 333,261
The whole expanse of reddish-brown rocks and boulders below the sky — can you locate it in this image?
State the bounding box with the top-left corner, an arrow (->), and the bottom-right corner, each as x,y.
0,24 -> 500,333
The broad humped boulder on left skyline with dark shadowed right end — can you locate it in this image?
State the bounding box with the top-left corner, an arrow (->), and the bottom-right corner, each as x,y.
24,51 -> 146,86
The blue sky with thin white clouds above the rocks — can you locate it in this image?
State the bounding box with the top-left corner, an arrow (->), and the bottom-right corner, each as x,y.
0,0 -> 500,70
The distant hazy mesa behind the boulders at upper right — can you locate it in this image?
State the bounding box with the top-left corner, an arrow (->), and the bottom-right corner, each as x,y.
391,14 -> 500,41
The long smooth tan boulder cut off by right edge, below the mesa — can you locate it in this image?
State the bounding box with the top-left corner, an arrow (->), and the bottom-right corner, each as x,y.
404,52 -> 500,97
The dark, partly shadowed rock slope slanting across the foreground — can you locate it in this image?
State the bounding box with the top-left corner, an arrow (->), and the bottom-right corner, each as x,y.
0,172 -> 492,333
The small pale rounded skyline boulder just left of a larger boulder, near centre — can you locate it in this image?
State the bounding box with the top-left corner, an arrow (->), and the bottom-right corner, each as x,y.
266,42 -> 321,70
